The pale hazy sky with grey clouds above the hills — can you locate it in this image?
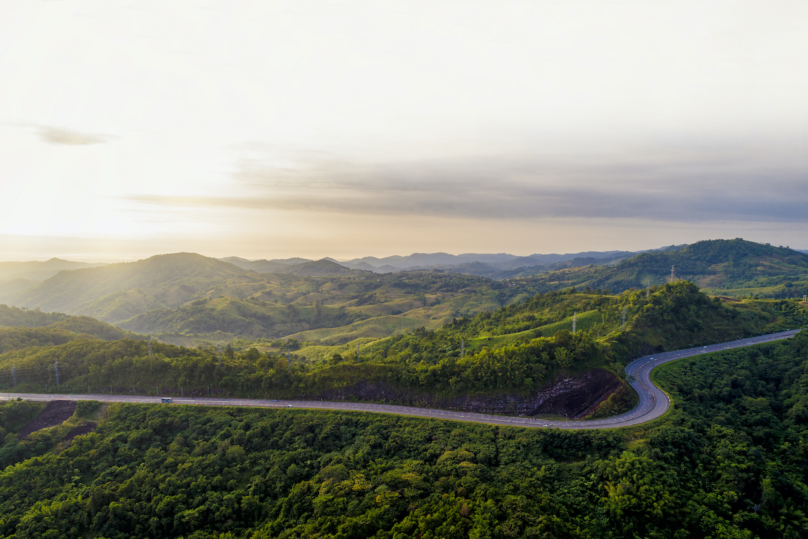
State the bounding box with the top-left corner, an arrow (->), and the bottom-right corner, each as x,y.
0,0 -> 808,260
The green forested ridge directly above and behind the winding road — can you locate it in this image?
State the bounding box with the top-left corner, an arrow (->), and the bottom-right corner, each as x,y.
0,282 -> 808,412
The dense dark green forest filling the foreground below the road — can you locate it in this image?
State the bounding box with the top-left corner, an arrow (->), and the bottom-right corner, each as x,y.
0,335 -> 808,539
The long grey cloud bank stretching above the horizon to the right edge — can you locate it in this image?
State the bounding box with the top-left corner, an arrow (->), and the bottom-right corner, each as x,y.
127,147 -> 808,223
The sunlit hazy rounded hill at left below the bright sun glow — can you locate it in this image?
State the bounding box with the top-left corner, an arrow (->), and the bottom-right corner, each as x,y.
16,253 -> 249,322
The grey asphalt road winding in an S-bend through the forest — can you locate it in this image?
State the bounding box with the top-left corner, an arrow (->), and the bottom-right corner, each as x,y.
0,329 -> 800,430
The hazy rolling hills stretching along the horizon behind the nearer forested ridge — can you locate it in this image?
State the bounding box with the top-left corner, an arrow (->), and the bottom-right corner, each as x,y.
0,239 -> 808,339
